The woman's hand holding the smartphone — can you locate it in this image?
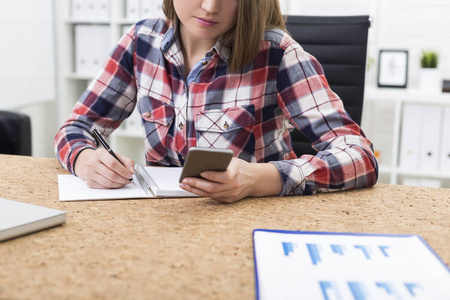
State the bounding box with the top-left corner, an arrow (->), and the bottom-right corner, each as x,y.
180,158 -> 282,203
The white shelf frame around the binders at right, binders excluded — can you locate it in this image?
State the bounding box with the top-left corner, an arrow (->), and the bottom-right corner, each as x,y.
363,87 -> 450,188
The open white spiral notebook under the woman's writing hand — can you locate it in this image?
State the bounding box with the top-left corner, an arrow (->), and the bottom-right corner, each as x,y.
58,165 -> 198,201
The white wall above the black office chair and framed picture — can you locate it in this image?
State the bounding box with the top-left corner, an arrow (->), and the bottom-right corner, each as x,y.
280,0 -> 450,87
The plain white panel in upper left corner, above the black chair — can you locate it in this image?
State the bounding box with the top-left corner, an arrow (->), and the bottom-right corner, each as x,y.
0,0 -> 55,109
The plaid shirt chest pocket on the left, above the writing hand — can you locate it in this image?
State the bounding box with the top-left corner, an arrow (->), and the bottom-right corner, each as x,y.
138,96 -> 175,162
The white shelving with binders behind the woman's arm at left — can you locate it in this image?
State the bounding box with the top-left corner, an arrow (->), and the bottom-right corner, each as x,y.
54,0 -> 163,163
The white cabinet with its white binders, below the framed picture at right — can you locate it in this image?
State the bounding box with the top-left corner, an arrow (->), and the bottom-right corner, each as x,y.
362,87 -> 450,188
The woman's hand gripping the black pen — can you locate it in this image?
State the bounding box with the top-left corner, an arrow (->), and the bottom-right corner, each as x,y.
75,148 -> 134,189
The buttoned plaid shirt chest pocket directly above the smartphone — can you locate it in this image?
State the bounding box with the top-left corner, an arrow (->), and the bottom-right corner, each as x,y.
195,105 -> 255,159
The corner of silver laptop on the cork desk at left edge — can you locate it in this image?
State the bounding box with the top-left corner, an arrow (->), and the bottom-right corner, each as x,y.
0,198 -> 66,242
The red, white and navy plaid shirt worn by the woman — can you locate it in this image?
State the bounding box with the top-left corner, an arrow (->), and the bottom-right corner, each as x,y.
55,19 -> 378,195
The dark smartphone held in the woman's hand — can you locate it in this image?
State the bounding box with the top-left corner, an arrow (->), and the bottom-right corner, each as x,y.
179,147 -> 233,182
